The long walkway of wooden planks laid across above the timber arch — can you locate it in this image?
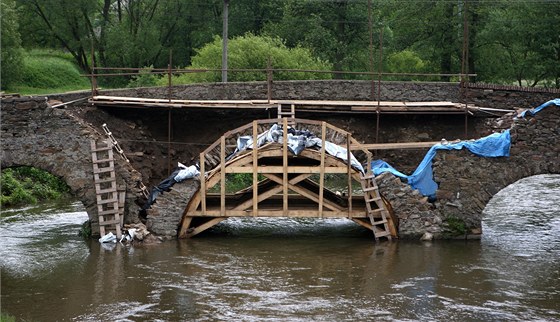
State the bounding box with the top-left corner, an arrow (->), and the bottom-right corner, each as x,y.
89,96 -> 500,115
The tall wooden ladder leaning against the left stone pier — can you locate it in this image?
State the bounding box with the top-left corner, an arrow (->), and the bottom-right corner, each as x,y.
91,140 -> 125,239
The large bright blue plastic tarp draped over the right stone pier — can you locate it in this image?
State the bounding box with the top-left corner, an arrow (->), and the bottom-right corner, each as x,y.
371,130 -> 511,198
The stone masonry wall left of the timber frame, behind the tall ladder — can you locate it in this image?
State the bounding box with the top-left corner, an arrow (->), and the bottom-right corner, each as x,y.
0,97 -> 145,233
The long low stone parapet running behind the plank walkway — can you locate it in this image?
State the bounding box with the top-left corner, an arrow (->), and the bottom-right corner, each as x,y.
49,80 -> 558,109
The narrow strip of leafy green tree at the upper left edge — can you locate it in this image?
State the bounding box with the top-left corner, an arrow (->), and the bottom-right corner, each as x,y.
0,0 -> 23,89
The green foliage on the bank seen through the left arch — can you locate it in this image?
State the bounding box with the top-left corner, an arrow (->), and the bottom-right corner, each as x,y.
0,167 -> 70,206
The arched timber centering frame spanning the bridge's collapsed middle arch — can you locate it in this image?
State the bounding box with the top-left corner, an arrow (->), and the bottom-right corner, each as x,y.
179,117 -> 396,240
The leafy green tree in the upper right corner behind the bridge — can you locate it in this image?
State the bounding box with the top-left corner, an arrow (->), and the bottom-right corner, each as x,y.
480,2 -> 560,88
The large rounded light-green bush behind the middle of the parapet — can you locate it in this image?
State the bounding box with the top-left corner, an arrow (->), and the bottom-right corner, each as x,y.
166,34 -> 331,85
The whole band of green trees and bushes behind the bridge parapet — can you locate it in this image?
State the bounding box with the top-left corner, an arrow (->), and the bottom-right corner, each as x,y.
10,0 -> 560,88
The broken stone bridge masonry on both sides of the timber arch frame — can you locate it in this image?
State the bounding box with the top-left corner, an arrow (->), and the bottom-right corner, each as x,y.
0,97 -> 560,238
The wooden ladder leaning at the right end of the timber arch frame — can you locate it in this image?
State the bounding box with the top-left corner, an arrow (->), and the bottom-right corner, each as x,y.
360,172 -> 391,241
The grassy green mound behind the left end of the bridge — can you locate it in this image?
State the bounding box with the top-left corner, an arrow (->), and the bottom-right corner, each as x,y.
6,49 -> 91,95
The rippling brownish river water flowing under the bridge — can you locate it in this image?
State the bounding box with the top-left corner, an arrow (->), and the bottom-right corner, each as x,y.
0,175 -> 560,321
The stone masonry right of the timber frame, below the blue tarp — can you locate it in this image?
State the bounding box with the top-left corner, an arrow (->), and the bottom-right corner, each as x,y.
377,105 -> 560,238
